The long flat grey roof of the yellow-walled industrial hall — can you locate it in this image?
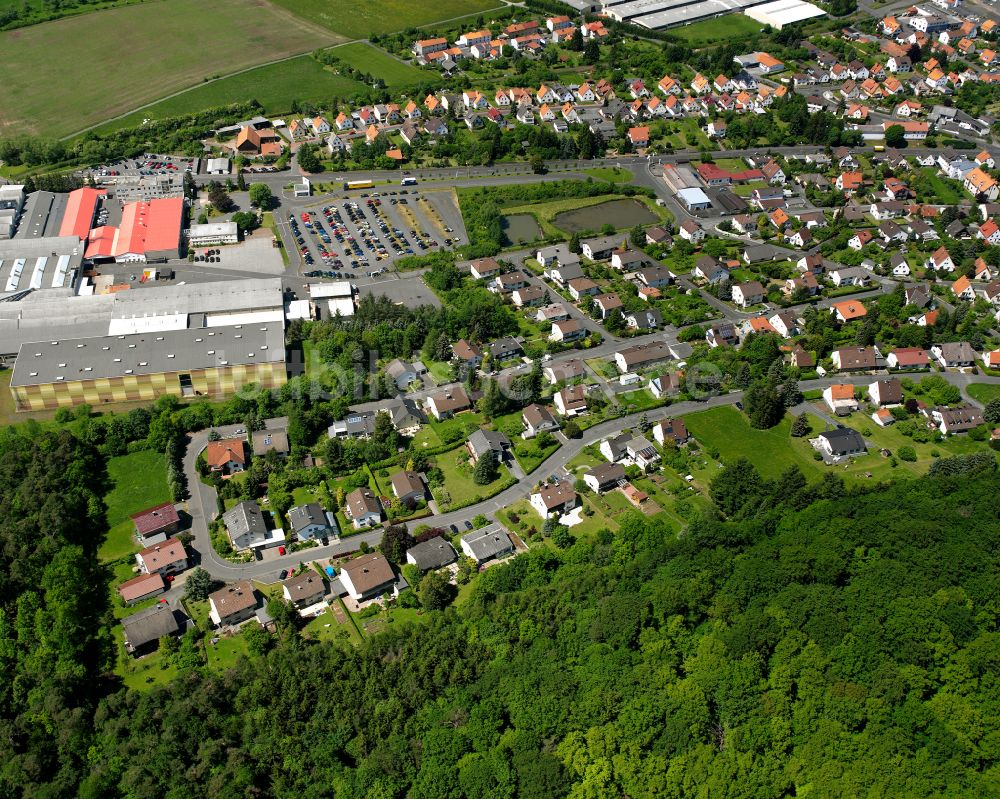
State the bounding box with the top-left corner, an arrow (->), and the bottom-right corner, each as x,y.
11,322 -> 285,386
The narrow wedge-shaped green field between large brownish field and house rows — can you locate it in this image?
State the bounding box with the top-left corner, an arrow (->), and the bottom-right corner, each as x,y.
97,55 -> 365,133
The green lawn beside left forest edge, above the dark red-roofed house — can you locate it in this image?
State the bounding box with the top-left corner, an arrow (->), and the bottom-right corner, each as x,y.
98,450 -> 170,563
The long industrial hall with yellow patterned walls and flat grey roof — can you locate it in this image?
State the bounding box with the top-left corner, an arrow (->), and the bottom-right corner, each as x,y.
10,323 -> 287,411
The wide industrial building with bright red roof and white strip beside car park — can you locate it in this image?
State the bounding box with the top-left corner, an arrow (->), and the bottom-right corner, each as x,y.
85,197 -> 184,263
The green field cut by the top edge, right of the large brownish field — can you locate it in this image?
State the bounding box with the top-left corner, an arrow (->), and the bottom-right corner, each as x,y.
275,0 -> 501,39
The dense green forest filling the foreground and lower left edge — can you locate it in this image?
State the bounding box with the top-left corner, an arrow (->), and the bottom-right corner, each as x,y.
0,410 -> 1000,799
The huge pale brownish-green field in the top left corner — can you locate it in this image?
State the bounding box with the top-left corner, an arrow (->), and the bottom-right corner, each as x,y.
0,0 -> 337,136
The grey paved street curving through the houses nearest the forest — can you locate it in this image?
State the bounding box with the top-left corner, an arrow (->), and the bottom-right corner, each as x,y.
184,372 -> 1000,581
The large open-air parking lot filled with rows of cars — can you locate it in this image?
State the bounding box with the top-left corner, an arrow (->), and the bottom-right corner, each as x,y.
280,189 -> 466,278
